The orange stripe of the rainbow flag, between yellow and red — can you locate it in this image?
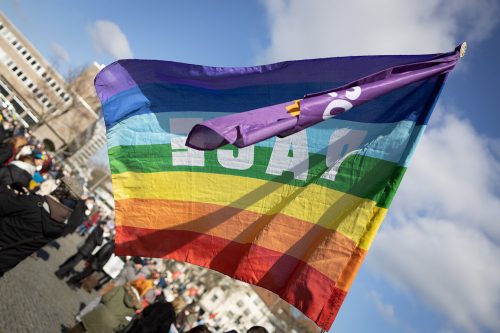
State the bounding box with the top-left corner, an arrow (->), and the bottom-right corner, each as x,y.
115,199 -> 358,290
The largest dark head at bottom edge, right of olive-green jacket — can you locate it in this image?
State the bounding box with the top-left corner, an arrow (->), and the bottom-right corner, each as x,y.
121,302 -> 178,333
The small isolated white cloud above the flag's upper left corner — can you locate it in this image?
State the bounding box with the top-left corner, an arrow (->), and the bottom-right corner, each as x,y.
87,20 -> 133,59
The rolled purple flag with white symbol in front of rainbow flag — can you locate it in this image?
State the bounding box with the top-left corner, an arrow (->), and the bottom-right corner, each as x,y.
186,48 -> 459,150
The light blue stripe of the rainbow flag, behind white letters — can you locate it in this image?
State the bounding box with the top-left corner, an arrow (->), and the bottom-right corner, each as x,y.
107,111 -> 425,166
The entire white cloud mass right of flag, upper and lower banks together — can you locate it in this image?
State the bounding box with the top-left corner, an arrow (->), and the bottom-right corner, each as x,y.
368,115 -> 500,332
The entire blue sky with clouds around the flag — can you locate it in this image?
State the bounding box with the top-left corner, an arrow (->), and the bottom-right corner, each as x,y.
2,0 -> 500,333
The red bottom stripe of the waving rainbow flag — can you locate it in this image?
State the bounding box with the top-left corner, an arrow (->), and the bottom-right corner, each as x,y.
116,226 -> 347,330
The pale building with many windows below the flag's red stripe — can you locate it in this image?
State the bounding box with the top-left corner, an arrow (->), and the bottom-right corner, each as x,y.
165,260 -> 320,333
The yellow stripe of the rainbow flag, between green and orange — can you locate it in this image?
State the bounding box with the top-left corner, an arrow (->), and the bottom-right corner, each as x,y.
112,172 -> 386,249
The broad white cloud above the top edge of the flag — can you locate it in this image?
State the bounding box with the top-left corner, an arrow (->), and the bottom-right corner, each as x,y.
257,0 -> 499,63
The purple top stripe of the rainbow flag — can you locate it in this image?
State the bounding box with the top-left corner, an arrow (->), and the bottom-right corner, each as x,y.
95,54 -> 439,103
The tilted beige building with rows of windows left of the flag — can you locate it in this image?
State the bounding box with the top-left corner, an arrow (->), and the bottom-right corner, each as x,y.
0,12 -> 100,151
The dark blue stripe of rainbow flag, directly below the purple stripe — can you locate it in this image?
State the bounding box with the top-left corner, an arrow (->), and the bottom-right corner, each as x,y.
103,77 -> 442,129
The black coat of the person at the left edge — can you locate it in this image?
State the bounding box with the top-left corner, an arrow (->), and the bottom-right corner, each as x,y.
0,190 -> 81,276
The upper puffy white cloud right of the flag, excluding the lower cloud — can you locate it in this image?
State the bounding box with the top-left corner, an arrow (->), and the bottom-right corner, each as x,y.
392,115 -> 500,239
